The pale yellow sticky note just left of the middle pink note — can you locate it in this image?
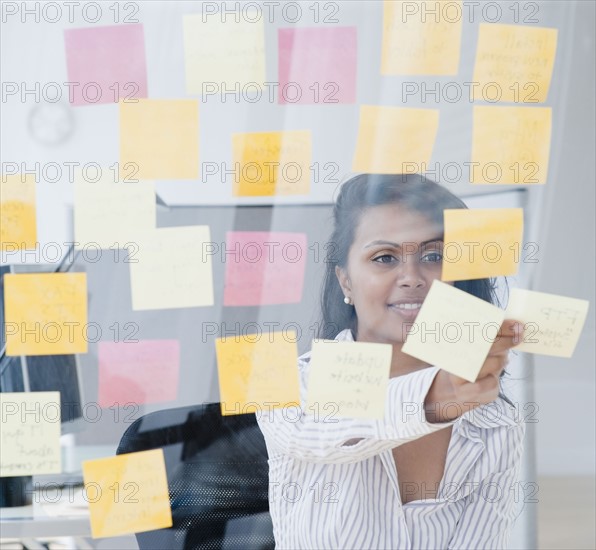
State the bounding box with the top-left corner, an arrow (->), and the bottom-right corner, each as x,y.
128,225 -> 213,311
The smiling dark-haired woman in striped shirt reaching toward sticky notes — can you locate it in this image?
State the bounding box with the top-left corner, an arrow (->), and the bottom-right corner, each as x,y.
259,174 -> 524,550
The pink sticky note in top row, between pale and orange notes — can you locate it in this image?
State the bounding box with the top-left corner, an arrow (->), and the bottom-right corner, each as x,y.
278,27 -> 357,105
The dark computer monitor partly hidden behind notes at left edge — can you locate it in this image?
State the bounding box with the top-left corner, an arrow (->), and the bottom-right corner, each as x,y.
0,265 -> 84,434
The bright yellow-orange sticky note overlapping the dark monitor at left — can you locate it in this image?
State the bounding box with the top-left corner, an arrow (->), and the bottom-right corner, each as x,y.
4,273 -> 87,355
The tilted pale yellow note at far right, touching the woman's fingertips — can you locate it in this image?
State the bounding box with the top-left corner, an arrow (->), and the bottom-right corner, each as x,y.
506,288 -> 590,357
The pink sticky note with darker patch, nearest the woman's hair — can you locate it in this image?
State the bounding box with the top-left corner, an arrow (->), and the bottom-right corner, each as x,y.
224,231 -> 307,306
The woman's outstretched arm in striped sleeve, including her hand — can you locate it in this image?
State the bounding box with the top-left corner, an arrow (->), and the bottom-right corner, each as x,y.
257,320 -> 521,463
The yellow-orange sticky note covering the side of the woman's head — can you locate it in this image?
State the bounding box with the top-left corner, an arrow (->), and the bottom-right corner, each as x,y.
441,208 -> 524,281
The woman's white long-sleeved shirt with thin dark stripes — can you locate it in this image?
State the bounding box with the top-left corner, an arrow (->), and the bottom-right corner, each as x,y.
258,330 -> 525,550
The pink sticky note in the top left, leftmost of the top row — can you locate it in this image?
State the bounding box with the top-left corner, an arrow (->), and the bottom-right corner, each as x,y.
64,23 -> 147,105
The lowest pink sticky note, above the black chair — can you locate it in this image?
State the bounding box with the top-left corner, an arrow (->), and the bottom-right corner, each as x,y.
98,340 -> 180,408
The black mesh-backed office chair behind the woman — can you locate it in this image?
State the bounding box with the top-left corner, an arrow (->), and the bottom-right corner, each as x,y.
116,403 -> 275,550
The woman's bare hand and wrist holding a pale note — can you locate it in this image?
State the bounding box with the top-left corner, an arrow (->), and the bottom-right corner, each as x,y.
424,319 -> 523,423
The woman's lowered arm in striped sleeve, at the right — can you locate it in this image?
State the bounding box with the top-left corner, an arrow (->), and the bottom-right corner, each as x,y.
449,424 -> 525,550
